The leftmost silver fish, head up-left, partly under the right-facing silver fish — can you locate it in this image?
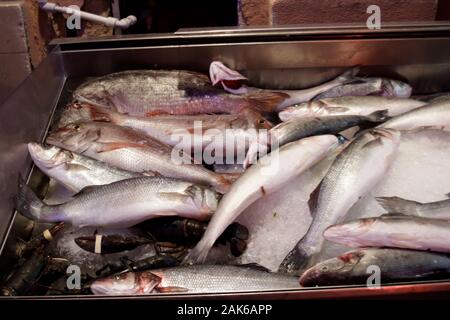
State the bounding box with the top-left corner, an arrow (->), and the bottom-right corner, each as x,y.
28,142 -> 142,192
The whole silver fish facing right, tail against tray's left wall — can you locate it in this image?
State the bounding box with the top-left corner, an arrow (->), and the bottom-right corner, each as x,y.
15,177 -> 218,228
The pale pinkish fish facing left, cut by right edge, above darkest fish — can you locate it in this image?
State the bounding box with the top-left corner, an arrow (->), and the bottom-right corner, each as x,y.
323,213 -> 450,252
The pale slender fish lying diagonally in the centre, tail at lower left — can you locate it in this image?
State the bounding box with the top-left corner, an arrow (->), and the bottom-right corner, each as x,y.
184,135 -> 338,263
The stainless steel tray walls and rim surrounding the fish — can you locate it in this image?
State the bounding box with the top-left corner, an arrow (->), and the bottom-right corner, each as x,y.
0,23 -> 450,299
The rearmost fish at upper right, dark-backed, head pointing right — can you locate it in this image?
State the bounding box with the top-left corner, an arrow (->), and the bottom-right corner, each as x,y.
314,77 -> 412,100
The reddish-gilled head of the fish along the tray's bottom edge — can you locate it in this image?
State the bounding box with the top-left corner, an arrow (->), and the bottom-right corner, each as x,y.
91,272 -> 161,295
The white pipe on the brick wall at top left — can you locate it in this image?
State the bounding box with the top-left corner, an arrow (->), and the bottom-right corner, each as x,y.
39,0 -> 137,29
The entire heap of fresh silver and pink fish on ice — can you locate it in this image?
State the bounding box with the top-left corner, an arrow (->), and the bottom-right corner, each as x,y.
5,62 -> 450,294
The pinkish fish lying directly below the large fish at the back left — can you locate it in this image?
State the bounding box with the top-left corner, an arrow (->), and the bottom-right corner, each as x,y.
60,103 -> 272,152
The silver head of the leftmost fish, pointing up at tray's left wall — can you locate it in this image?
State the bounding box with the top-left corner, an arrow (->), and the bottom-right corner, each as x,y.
28,142 -> 73,169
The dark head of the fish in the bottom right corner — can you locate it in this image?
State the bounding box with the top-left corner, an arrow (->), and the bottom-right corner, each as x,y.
300,250 -> 364,287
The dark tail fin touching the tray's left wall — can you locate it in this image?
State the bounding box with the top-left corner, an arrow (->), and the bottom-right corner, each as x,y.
15,177 -> 61,222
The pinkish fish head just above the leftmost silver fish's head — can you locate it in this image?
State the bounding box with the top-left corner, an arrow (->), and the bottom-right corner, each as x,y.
46,123 -> 101,153
